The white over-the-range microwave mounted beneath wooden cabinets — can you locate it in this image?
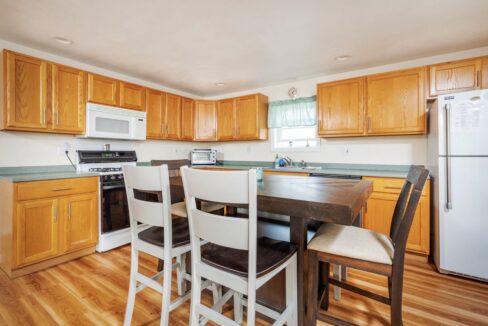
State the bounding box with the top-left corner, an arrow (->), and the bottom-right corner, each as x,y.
84,103 -> 147,140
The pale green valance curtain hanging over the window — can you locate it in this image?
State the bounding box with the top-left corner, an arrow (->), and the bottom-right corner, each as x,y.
268,96 -> 317,128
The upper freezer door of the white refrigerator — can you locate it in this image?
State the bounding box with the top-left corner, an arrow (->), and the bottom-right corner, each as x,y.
437,90 -> 488,156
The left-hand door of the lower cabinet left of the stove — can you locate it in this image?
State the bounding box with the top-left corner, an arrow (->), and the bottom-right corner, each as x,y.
14,199 -> 59,266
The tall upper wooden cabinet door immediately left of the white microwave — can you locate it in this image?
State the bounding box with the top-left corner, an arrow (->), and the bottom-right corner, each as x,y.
52,64 -> 86,134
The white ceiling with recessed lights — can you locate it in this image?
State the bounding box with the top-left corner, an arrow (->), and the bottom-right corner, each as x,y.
0,0 -> 488,96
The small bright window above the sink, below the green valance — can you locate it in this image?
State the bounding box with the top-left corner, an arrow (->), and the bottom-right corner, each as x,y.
271,126 -> 320,152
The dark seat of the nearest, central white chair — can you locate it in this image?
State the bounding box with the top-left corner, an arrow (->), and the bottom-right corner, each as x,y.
202,237 -> 296,277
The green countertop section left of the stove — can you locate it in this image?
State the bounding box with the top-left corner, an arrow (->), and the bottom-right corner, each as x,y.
0,165 -> 99,182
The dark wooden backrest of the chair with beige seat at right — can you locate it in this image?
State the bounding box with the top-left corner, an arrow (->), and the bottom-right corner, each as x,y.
390,165 -> 429,260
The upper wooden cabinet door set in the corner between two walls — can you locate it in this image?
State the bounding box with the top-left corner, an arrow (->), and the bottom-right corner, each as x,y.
195,101 -> 217,140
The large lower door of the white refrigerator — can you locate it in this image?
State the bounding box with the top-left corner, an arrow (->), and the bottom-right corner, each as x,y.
436,157 -> 488,279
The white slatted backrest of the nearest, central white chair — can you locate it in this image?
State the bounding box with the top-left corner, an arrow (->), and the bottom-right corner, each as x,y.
181,167 -> 257,278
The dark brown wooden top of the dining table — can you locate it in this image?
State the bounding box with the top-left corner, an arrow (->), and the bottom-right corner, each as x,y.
171,175 -> 373,225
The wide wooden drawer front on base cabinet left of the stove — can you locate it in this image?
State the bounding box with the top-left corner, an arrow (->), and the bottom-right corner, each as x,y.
16,177 -> 98,201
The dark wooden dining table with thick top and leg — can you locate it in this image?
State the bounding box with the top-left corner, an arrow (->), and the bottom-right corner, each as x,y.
170,175 -> 373,325
